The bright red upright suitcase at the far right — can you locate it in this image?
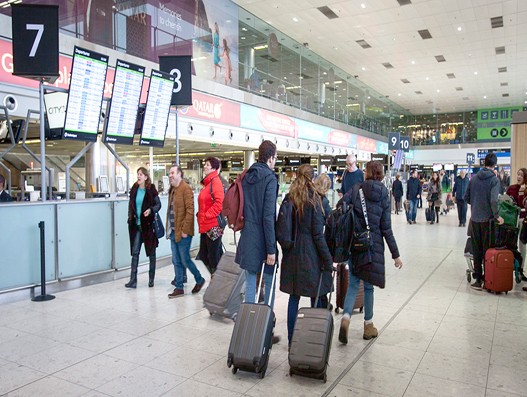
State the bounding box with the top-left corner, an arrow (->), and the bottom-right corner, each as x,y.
485,248 -> 514,293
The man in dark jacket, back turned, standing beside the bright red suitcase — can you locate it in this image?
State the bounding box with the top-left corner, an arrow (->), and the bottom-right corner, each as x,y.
465,153 -> 503,290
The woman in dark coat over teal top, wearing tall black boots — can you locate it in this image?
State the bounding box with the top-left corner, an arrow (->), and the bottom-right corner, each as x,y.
125,167 -> 161,288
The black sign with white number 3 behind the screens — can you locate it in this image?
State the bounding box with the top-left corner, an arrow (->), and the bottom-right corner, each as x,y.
159,55 -> 196,106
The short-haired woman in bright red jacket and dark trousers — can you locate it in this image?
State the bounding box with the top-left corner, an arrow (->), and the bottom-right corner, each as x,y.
198,157 -> 225,274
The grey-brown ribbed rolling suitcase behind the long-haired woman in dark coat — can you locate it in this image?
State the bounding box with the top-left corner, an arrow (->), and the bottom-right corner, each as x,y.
289,274 -> 335,383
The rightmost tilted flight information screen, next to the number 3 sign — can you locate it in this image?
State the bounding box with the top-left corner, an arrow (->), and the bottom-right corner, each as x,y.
139,70 -> 174,147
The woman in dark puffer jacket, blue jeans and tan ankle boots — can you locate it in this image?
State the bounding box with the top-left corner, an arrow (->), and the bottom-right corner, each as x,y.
339,161 -> 403,344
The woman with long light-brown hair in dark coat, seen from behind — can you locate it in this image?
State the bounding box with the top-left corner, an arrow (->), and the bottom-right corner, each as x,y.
280,164 -> 333,344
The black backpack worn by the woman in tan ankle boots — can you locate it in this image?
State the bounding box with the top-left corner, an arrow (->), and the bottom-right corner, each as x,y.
324,200 -> 355,263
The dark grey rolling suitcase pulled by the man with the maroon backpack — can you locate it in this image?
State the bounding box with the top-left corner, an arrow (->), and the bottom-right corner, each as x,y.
227,263 -> 276,379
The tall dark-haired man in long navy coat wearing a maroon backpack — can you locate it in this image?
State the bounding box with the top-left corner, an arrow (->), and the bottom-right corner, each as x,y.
236,141 -> 278,307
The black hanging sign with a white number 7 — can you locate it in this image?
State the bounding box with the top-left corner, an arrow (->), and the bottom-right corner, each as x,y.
11,4 -> 59,82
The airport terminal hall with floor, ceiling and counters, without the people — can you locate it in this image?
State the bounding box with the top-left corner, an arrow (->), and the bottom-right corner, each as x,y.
0,0 -> 527,397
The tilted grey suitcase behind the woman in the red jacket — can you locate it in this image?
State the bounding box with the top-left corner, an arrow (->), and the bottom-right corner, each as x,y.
203,251 -> 245,320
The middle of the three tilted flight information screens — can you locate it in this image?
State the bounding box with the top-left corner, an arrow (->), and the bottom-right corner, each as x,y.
104,60 -> 145,145
